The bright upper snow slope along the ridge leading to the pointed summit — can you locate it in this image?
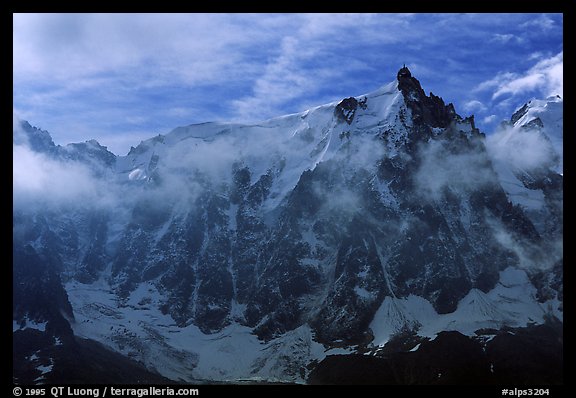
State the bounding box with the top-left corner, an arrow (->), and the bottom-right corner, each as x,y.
115,81 -> 410,210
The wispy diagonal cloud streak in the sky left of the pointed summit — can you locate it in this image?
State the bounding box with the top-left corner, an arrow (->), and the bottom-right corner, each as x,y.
225,14 -> 410,121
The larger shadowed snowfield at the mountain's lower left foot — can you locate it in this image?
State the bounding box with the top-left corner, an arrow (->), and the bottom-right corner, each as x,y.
66,280 -> 348,383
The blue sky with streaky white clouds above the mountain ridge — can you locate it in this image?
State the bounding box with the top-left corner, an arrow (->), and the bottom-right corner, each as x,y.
13,14 -> 563,155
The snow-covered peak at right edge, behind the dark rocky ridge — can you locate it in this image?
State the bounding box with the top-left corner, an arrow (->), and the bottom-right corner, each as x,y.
487,96 -> 563,262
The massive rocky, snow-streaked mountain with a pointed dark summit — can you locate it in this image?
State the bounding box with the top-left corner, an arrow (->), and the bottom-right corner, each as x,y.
13,67 -> 563,383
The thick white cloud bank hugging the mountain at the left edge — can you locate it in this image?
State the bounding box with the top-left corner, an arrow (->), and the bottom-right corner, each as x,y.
12,120 -> 200,218
